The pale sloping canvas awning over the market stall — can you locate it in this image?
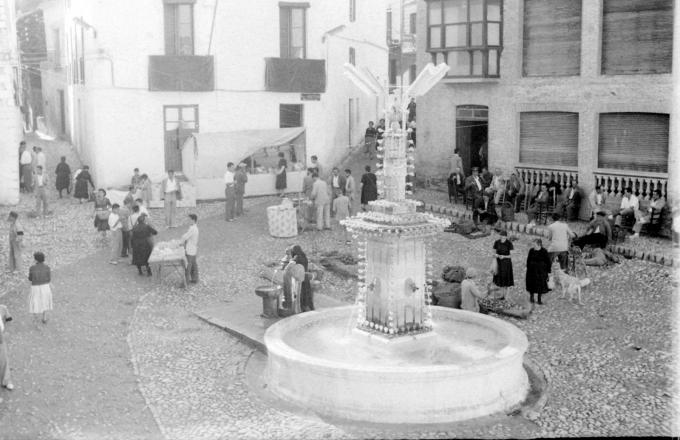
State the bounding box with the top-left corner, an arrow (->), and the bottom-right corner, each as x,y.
182,127 -> 305,179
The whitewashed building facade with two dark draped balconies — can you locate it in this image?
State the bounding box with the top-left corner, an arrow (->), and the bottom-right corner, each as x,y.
40,0 -> 388,192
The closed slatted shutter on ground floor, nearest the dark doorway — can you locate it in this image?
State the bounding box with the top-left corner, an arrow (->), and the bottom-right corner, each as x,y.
519,112 -> 578,167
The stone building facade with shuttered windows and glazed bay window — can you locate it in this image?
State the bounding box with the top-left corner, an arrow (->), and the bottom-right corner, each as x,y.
416,0 -> 673,219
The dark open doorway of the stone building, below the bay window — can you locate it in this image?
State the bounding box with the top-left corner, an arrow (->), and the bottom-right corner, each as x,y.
456,105 -> 489,176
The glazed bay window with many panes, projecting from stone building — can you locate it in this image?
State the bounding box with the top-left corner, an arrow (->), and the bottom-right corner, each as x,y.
427,0 -> 503,77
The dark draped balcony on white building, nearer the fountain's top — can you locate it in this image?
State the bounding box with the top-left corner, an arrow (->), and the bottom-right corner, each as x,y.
265,58 -> 326,93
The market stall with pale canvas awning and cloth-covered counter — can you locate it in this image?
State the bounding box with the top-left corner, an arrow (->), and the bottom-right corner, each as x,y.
182,127 -> 307,200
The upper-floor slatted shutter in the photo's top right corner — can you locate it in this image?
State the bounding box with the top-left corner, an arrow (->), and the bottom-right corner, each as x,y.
602,0 -> 673,75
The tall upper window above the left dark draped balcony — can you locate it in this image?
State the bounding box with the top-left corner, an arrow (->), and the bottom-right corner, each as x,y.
163,0 -> 194,55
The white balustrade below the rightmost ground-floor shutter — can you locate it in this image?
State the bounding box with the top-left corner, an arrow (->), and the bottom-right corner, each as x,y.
594,171 -> 668,200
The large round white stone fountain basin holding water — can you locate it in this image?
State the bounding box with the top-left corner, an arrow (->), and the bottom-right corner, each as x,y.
264,306 -> 529,424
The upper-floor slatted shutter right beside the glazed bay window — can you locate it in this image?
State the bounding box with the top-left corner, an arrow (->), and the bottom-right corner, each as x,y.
523,0 -> 581,76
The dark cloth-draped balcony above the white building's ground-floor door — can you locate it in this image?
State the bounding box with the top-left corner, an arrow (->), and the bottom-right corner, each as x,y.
149,55 -> 215,92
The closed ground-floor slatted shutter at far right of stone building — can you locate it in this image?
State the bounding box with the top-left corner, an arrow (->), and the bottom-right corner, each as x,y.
597,113 -> 669,173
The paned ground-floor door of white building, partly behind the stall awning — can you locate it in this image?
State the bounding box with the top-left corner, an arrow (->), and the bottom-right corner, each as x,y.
163,105 -> 198,171
